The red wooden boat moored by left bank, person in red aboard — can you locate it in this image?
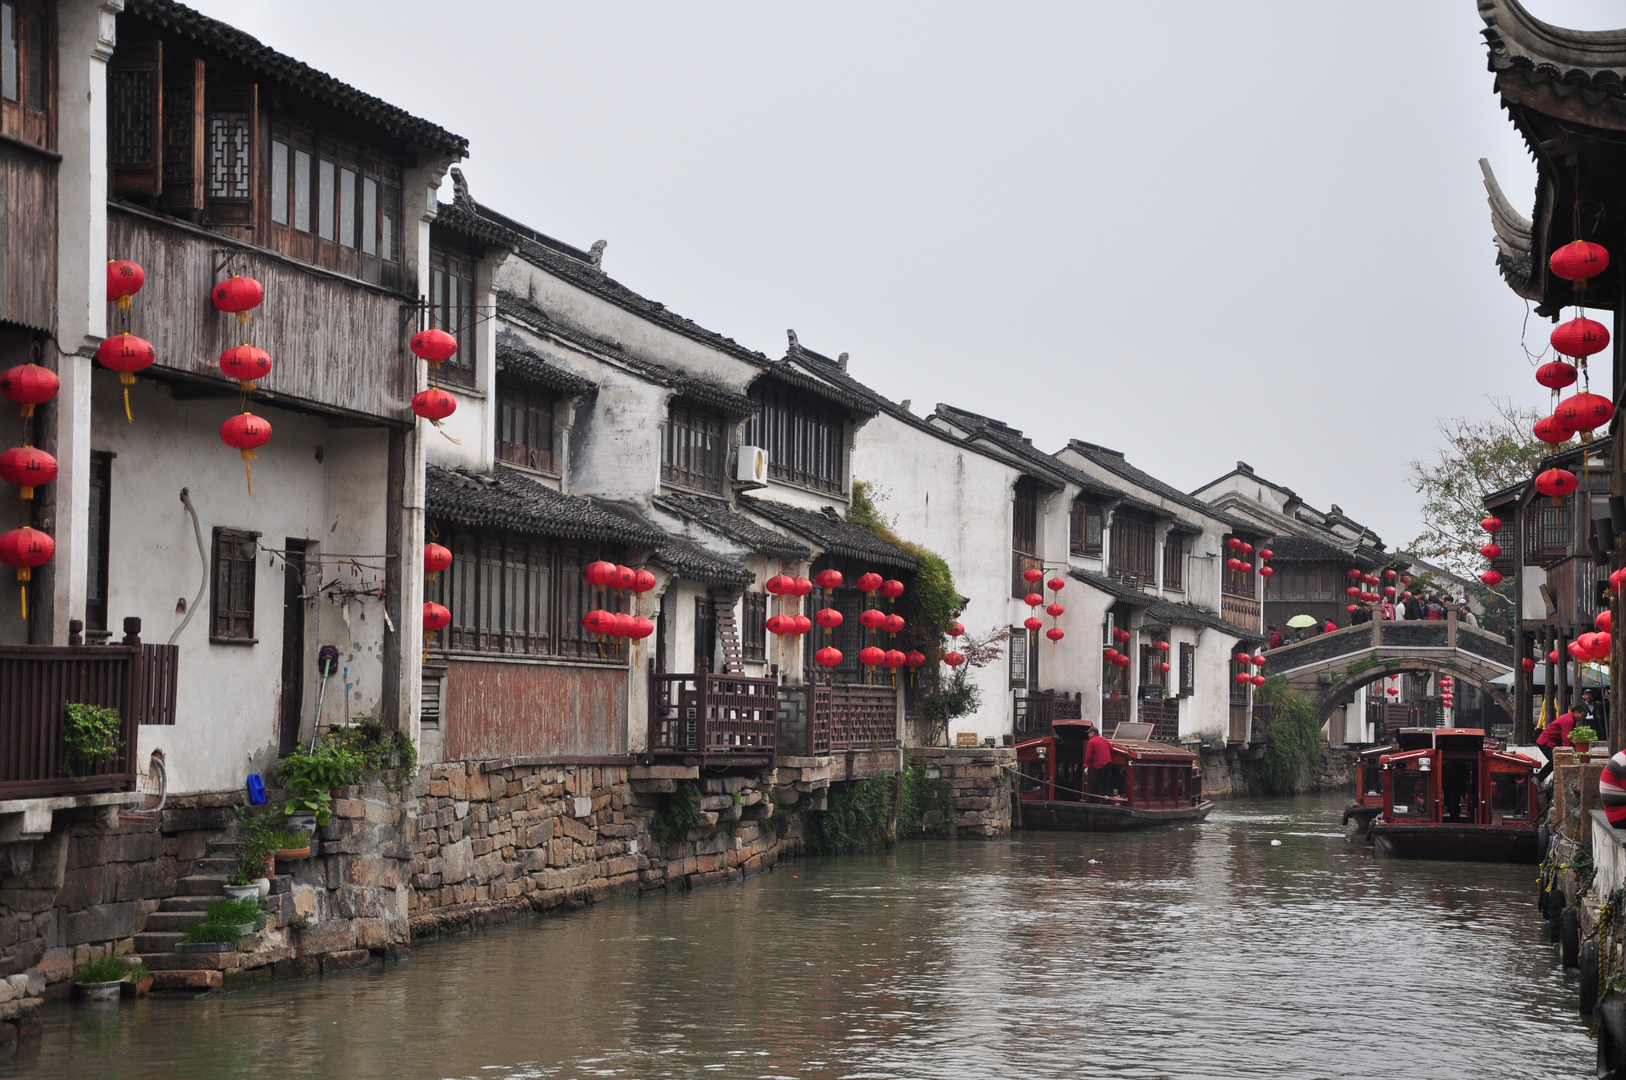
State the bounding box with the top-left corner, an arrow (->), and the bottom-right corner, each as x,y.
1016,721 -> 1213,833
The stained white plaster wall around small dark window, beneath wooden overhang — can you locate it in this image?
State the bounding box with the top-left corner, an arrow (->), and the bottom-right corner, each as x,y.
91,372 -> 387,794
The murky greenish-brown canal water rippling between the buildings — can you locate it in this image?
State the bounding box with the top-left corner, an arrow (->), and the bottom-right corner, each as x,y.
0,797 -> 1593,1080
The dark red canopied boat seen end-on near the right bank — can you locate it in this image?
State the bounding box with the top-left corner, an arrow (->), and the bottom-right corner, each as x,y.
1371,727 -> 1541,862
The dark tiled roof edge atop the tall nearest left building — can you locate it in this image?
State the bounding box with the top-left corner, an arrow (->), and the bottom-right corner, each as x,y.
124,0 -> 468,158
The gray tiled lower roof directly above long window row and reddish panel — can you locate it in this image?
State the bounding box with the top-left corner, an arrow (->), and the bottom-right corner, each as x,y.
424,465 -> 667,547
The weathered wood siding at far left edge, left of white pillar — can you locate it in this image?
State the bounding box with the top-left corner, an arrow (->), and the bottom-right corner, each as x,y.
0,142 -> 57,332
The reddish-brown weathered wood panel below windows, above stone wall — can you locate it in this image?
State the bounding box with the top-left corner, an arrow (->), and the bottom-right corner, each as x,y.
441,660 -> 626,761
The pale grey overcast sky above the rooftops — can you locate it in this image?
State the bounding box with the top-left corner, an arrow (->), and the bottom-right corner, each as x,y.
193,0 -> 1626,547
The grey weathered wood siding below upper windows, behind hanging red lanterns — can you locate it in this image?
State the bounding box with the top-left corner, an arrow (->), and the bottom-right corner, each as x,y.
107,207 -> 418,425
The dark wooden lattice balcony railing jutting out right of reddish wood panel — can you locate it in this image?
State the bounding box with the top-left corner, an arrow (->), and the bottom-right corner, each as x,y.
649,670 -> 779,756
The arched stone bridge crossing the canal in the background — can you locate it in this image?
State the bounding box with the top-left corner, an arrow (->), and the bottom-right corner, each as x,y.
1265,616 -> 1514,721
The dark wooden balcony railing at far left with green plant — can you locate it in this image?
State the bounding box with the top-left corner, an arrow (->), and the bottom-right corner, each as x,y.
0,642 -> 177,799
